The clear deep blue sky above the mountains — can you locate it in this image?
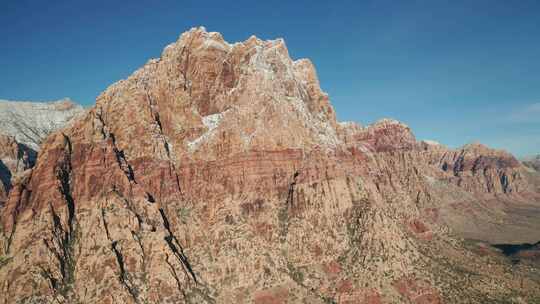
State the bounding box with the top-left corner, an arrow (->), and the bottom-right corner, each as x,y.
0,0 -> 540,156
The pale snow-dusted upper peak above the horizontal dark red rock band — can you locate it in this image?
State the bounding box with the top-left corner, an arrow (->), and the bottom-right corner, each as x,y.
90,28 -> 341,163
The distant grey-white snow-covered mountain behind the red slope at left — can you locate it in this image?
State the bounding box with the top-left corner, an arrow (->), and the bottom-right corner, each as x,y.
0,98 -> 84,151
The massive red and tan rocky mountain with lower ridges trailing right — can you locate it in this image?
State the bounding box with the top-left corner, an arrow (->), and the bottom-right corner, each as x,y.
0,28 -> 540,303
